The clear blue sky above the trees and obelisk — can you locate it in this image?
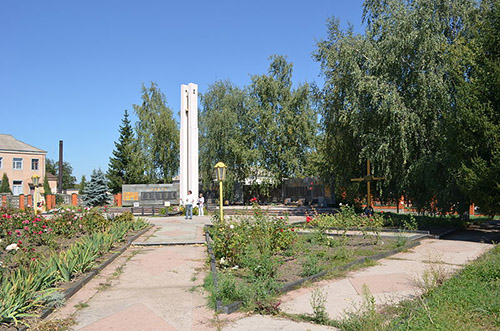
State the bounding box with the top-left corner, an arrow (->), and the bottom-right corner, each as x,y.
0,0 -> 363,182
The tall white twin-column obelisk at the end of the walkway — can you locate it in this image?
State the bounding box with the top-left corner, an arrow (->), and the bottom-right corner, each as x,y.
179,83 -> 199,202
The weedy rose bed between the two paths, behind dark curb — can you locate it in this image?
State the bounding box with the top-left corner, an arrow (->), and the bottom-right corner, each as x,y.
205,203 -> 418,313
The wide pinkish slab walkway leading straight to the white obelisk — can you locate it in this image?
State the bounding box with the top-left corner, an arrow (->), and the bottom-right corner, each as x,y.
49,216 -> 331,331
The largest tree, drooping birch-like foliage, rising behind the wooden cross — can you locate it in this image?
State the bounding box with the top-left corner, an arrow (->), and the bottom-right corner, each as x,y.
315,0 -> 492,211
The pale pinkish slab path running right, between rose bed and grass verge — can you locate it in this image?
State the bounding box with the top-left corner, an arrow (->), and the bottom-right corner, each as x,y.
280,239 -> 492,319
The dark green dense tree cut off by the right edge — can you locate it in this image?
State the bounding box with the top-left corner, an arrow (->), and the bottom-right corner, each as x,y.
454,0 -> 500,215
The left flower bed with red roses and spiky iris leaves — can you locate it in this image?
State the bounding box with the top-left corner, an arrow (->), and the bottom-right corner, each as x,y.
0,209 -> 147,324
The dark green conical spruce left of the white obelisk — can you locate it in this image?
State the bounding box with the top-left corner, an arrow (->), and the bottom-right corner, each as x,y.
106,110 -> 135,194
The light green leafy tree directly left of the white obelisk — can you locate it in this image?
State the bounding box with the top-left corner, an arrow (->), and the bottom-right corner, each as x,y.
133,82 -> 179,183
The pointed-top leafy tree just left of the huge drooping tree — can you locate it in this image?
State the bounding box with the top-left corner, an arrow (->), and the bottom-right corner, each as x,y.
249,55 -> 316,188
